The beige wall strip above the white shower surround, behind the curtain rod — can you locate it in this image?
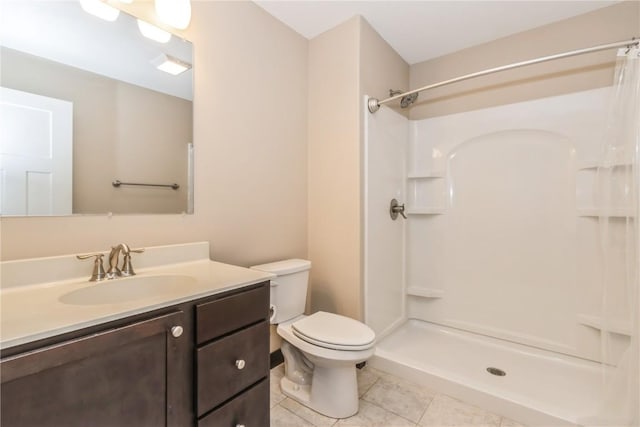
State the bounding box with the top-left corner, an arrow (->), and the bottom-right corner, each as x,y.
410,1 -> 640,119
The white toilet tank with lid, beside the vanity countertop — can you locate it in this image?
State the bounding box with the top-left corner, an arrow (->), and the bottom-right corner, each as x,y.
251,259 -> 311,323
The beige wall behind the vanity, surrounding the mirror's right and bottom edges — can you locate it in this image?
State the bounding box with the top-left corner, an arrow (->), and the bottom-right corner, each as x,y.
0,2 -> 307,266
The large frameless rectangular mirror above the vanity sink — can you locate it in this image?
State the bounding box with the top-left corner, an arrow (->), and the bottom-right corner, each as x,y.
0,0 -> 193,216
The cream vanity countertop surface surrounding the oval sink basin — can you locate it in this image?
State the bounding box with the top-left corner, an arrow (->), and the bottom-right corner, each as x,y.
0,246 -> 273,349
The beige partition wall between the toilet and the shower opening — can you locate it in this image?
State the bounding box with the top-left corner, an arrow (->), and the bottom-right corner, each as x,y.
308,17 -> 409,319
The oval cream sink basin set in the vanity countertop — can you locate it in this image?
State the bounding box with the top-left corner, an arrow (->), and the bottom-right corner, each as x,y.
60,275 -> 195,305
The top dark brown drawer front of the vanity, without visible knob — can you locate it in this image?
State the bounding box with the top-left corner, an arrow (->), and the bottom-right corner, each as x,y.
196,282 -> 269,344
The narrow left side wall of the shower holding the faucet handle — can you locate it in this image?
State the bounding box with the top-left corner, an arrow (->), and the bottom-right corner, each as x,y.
363,99 -> 409,337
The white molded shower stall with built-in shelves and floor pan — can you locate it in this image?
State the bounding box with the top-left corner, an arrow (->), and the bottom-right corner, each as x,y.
364,61 -> 637,425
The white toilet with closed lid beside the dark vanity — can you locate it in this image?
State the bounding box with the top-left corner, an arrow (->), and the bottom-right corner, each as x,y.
251,259 -> 376,418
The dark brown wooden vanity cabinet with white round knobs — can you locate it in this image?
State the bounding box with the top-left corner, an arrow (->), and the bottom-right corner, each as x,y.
0,282 -> 269,427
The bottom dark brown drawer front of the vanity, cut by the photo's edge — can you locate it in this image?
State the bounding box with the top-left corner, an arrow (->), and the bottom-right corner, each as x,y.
198,379 -> 269,427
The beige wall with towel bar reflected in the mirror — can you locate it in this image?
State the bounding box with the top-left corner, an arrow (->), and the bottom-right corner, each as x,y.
0,48 -> 193,214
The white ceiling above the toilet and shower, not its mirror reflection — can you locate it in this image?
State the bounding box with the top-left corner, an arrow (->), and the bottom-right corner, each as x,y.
255,0 -> 618,64
